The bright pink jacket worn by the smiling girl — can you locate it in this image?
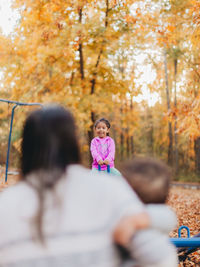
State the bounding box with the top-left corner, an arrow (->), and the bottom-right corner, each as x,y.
90,136 -> 115,170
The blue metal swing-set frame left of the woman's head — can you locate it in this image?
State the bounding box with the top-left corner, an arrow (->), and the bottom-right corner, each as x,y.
0,99 -> 42,183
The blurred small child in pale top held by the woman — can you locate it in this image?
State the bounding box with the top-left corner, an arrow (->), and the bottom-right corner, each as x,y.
115,157 -> 178,267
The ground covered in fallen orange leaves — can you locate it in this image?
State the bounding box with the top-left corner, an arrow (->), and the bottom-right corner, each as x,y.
0,175 -> 200,267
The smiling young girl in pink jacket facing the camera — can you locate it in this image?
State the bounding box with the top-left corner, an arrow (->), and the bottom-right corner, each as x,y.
90,118 -> 121,175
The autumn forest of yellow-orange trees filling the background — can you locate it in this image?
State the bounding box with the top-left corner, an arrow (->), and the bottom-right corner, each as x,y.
0,0 -> 200,182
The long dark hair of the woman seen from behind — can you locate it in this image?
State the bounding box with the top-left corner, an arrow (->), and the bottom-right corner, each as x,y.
21,105 -> 81,244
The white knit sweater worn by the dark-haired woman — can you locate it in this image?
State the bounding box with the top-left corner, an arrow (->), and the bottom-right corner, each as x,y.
0,165 -> 144,267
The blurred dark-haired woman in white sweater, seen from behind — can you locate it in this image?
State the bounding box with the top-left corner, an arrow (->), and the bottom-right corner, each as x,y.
0,105 -> 149,267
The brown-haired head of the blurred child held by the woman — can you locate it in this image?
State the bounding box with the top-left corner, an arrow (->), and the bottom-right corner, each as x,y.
121,157 -> 171,203
